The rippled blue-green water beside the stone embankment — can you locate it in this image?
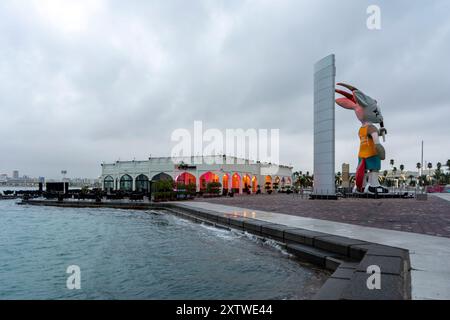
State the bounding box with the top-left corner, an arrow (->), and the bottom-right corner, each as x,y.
0,201 -> 327,299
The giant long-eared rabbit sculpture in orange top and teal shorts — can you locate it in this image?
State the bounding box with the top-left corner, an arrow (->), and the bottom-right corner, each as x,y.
336,83 -> 389,194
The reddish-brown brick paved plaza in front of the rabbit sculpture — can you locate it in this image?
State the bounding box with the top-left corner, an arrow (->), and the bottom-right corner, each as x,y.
196,194 -> 450,238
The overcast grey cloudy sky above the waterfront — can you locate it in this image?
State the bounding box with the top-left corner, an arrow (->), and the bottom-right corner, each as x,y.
0,0 -> 450,177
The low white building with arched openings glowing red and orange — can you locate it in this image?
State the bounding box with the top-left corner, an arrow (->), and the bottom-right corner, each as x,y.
100,156 -> 292,193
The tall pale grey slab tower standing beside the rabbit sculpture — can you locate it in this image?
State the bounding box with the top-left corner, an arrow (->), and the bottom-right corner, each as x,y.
313,54 -> 336,199
